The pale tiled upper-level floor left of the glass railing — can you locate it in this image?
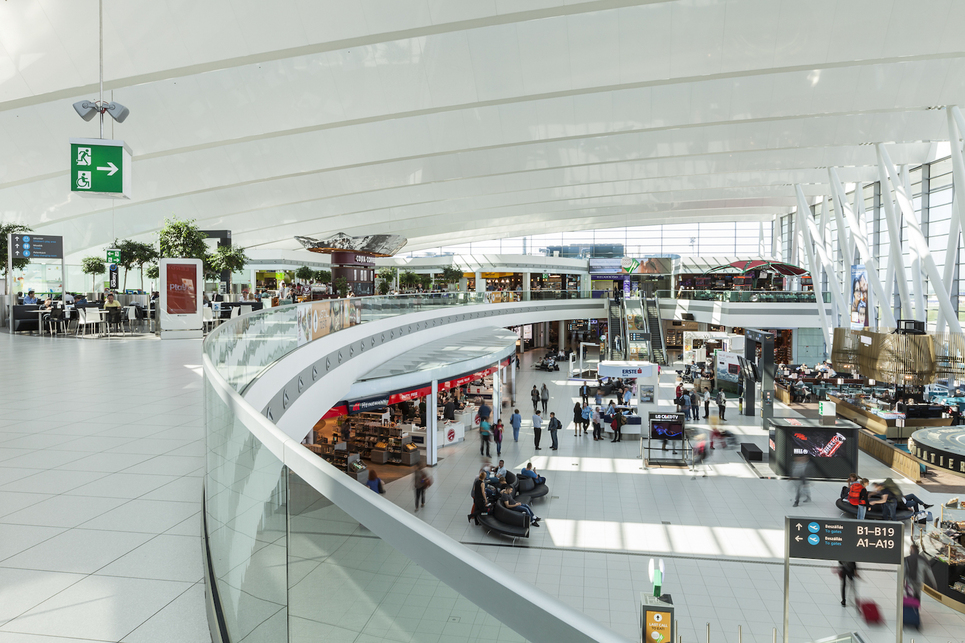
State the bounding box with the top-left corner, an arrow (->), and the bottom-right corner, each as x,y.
0,332 -> 210,643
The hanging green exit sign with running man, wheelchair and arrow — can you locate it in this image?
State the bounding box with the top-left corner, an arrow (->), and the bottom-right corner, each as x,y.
70,138 -> 131,199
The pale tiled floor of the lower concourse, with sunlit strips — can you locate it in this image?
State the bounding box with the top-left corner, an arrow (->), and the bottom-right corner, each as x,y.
378,351 -> 965,643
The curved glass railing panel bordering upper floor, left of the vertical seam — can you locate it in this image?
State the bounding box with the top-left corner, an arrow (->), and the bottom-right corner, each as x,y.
205,381 -> 288,643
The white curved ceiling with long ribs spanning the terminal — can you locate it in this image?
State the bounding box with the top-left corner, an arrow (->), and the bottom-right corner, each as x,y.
0,0 -> 965,258
